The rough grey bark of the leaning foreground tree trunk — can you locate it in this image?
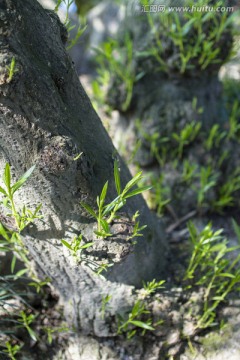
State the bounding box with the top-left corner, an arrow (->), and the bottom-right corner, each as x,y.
0,0 -> 167,336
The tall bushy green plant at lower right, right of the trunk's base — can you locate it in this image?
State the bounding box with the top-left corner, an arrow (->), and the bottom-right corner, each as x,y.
184,222 -> 240,328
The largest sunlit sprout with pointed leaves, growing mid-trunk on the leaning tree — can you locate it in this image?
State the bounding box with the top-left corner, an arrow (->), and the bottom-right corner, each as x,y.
81,160 -> 151,238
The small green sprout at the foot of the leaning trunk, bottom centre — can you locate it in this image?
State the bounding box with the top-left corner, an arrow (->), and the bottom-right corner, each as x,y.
118,300 -> 155,339
